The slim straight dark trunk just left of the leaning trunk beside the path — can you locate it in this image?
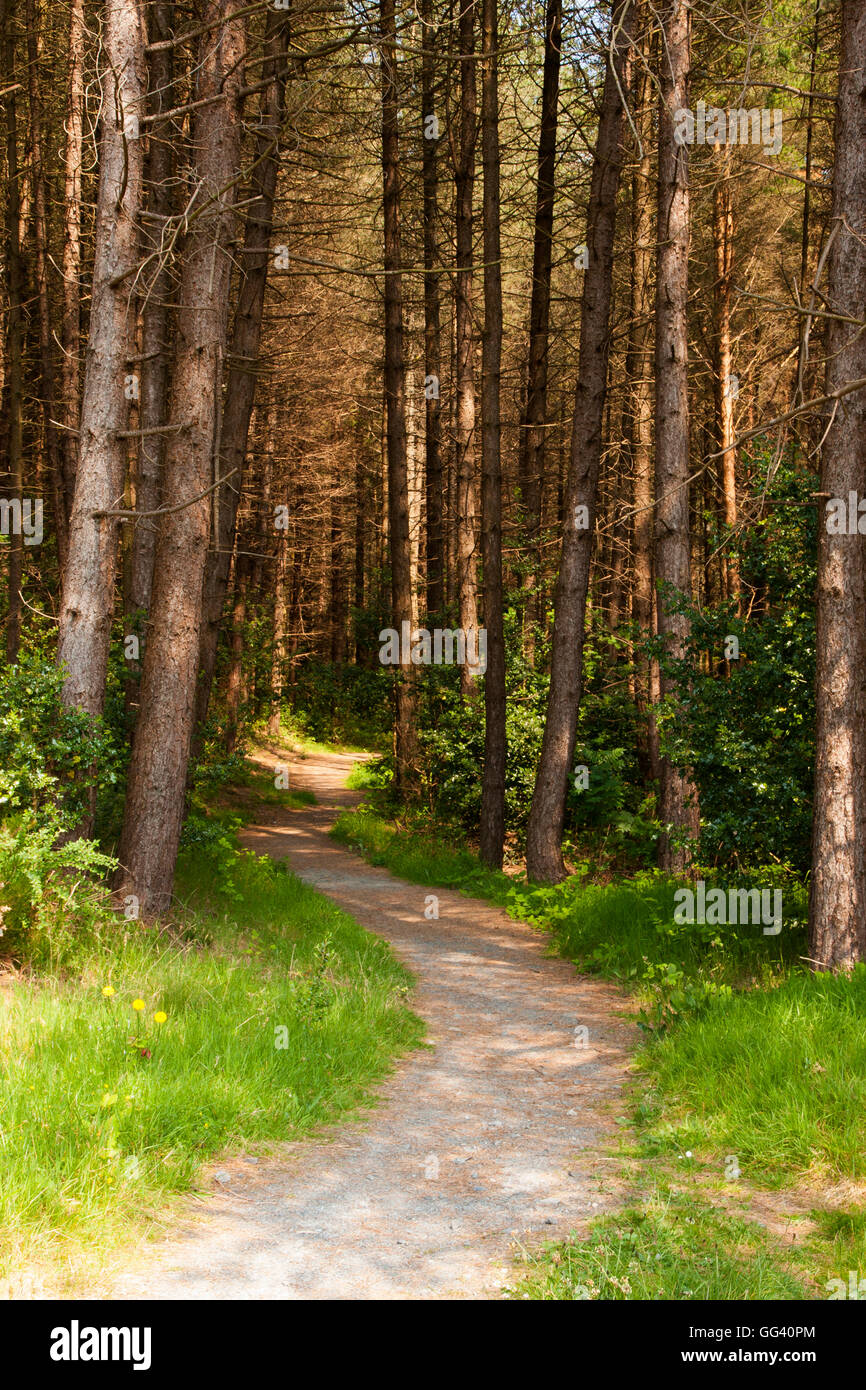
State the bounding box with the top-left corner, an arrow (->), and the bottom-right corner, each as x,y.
481,0 -> 506,869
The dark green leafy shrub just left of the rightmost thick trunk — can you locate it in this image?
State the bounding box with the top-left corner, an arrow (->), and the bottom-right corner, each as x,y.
659,464 -> 816,872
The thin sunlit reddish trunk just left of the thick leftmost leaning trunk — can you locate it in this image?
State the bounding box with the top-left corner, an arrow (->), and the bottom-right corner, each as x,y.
60,0 -> 85,530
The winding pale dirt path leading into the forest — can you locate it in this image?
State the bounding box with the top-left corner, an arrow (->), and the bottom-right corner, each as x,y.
114,753 -> 634,1298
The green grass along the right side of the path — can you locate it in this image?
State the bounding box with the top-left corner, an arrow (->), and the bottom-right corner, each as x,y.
332,789 -> 866,1298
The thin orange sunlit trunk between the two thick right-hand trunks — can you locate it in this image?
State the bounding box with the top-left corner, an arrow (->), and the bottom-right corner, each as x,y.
713,146 -> 740,605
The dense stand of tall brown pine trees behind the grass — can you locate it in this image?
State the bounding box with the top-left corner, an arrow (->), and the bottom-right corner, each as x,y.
0,0 -> 866,967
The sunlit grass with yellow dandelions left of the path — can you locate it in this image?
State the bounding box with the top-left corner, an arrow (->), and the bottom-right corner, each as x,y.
0,811 -> 423,1289
